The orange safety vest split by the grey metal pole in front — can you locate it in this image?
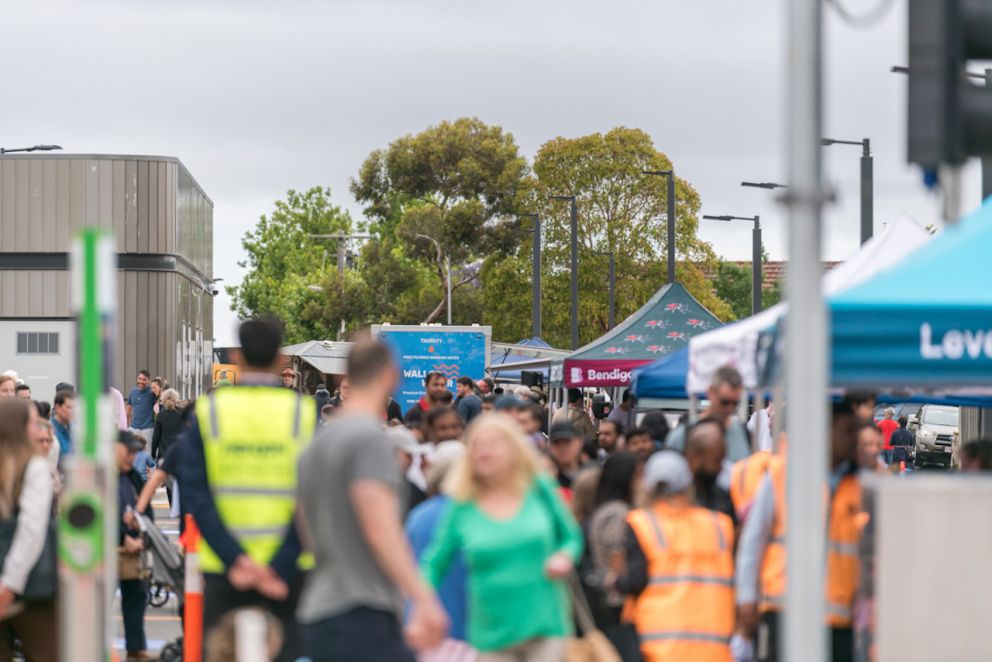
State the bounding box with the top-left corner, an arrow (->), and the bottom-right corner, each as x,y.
761,457 -> 864,627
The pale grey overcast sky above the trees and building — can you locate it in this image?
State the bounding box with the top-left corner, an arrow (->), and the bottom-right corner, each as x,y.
0,0 -> 979,345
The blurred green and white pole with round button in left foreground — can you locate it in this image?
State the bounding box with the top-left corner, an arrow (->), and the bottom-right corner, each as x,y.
59,228 -> 118,662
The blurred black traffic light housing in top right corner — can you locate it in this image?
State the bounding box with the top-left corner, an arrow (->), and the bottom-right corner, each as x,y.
907,0 -> 992,170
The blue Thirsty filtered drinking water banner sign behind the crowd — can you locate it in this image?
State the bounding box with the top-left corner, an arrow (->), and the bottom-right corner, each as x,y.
372,325 -> 492,412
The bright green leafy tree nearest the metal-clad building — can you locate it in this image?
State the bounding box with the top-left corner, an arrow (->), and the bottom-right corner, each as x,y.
226,186 -> 353,343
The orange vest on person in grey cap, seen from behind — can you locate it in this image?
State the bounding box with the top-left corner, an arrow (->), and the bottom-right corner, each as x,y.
627,501 -> 734,662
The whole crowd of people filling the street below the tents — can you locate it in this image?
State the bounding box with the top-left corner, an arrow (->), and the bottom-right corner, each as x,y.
0,320 -> 992,662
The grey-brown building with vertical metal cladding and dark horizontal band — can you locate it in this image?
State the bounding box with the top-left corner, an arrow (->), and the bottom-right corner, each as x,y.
0,154 -> 213,400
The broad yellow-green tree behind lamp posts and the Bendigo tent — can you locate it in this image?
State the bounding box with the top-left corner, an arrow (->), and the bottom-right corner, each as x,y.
482,127 -> 731,347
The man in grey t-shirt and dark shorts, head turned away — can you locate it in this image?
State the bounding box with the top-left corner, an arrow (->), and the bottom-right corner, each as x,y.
297,342 -> 447,662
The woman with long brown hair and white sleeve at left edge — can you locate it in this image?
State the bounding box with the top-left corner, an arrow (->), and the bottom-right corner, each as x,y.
0,398 -> 58,662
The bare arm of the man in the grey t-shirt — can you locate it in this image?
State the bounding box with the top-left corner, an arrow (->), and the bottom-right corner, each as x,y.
349,480 -> 448,650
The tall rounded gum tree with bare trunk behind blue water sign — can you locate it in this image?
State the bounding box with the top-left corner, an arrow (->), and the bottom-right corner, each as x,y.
351,118 -> 527,322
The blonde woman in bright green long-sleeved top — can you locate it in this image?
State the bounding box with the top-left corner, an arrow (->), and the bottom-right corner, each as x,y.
421,414 -> 582,662
